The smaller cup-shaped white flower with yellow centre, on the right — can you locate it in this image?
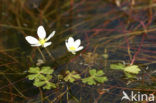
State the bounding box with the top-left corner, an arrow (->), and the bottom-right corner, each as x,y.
65,37 -> 83,54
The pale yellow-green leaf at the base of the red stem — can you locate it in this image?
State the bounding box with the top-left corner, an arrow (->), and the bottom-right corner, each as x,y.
124,65 -> 141,74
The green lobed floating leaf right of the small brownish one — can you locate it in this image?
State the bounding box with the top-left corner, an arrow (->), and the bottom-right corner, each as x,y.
82,69 -> 107,85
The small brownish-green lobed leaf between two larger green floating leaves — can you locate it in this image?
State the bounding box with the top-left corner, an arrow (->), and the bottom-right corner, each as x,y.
64,71 -> 81,83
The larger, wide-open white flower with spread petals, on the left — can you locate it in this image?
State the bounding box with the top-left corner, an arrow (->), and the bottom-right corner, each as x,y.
25,26 -> 55,47
